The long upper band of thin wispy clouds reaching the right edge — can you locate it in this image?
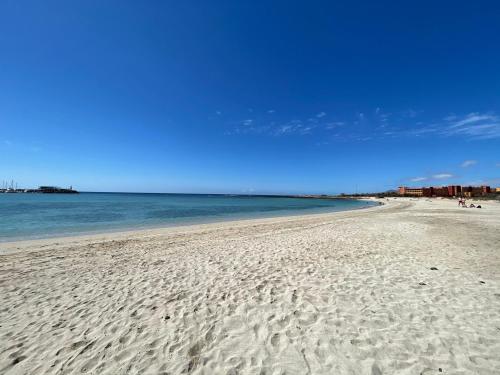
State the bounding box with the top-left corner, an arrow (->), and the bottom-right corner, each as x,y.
226,107 -> 500,144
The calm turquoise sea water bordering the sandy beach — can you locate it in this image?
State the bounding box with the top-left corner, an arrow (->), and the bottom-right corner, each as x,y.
0,193 -> 372,241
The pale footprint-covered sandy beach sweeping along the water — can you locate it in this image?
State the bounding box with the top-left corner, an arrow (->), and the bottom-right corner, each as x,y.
0,199 -> 500,375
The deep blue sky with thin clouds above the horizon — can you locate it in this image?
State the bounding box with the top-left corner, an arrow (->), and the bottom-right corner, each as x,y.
0,0 -> 500,193
